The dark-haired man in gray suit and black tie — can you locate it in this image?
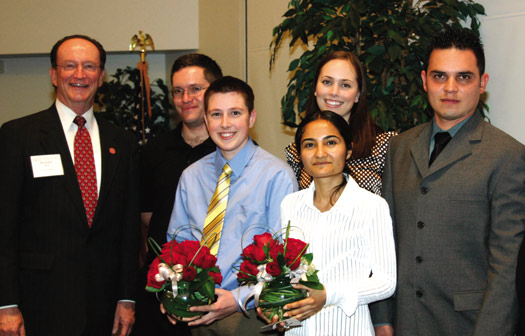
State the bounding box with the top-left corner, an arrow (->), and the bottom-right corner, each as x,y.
374,28 -> 525,336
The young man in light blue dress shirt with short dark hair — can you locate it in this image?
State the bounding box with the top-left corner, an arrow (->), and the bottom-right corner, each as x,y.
167,76 -> 297,335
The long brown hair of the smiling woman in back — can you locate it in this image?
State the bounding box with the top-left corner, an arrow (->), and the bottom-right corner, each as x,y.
306,51 -> 379,159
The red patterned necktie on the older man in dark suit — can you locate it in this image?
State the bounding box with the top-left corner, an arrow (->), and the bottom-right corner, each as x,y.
73,116 -> 97,227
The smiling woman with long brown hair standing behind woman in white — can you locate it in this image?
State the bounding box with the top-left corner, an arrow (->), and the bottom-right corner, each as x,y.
285,51 -> 396,194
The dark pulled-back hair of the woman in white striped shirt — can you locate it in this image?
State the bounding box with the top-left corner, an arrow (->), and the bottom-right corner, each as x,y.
295,110 -> 352,205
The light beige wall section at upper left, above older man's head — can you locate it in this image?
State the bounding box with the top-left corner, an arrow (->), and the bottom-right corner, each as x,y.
0,0 -> 199,55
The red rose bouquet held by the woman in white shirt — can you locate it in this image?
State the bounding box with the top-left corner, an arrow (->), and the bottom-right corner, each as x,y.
237,223 -> 323,321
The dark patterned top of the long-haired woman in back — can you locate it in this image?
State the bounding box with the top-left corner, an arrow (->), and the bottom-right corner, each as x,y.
284,131 -> 397,195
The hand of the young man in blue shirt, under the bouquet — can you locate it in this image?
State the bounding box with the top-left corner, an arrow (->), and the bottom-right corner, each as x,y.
188,288 -> 238,327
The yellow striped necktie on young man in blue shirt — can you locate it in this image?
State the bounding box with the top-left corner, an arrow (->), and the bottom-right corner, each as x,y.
202,164 -> 232,255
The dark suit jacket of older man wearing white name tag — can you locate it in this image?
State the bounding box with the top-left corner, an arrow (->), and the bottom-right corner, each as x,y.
0,105 -> 140,336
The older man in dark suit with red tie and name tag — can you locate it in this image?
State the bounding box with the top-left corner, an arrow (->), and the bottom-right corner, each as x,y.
0,35 -> 140,336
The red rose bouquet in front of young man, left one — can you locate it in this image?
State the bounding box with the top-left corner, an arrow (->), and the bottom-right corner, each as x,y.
146,239 -> 222,318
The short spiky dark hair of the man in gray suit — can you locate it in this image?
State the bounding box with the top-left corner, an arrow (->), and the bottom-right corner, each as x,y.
425,27 -> 485,76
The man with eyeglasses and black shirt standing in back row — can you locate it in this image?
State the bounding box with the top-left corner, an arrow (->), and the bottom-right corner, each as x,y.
133,53 -> 222,335
